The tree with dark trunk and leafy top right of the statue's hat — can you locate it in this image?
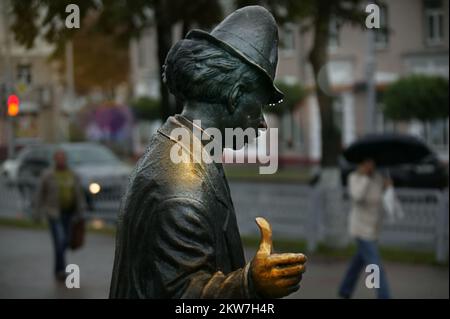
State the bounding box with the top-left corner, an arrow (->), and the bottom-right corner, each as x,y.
236,0 -> 365,167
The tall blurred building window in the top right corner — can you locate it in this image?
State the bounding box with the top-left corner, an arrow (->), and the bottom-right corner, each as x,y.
424,0 -> 444,46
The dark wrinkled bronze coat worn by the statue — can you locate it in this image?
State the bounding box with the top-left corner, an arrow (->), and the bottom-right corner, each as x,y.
110,116 -> 254,298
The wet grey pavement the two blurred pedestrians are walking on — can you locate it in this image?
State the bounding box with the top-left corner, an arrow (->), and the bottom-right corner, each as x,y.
0,226 -> 449,298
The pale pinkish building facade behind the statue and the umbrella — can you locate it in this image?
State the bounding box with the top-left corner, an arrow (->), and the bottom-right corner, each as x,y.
130,0 -> 449,163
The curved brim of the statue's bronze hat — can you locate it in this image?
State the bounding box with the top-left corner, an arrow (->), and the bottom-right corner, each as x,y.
186,29 -> 284,104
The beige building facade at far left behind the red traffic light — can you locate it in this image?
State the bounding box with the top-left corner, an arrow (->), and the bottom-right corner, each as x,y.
0,1 -> 59,154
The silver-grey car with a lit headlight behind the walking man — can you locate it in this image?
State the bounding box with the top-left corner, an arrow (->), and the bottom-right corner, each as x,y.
16,142 -> 132,210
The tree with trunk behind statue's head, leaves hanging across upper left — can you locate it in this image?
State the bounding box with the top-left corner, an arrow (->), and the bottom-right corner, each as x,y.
7,0 -> 222,119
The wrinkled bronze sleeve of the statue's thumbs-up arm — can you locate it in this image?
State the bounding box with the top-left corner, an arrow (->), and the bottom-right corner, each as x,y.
151,198 -> 254,299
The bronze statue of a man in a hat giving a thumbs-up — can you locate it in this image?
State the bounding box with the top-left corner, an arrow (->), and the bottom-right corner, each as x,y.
110,6 -> 306,298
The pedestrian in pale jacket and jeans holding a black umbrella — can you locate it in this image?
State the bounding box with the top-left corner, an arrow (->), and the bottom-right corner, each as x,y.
339,134 -> 432,298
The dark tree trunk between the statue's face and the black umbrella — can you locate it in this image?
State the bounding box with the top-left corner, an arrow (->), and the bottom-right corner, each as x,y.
309,1 -> 341,167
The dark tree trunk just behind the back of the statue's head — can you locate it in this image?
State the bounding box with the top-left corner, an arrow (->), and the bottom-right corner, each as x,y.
154,0 -> 175,122
